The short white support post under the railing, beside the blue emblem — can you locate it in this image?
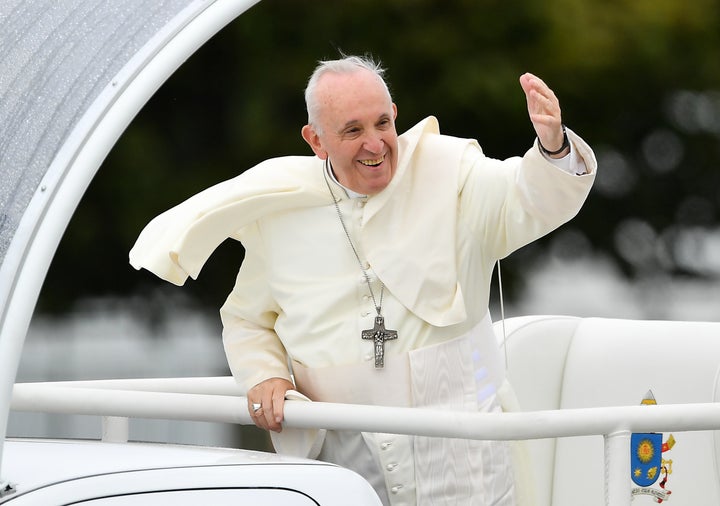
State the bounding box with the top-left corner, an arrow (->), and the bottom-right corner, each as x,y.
605,430 -> 632,506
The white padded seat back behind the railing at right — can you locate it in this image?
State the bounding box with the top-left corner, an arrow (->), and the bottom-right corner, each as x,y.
495,316 -> 720,506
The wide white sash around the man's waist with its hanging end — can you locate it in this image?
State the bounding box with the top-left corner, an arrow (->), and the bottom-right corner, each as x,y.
273,316 -> 514,506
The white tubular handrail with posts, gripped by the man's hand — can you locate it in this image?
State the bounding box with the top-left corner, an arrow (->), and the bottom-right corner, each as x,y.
11,378 -> 720,506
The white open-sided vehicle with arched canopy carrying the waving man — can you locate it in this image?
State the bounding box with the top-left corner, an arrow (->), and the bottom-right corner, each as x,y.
0,0 -> 720,506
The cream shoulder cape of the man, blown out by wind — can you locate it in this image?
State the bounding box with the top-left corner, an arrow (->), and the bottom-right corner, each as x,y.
130,117 -> 475,326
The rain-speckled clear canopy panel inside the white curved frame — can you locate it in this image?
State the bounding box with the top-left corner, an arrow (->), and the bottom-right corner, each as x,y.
0,0 -> 195,264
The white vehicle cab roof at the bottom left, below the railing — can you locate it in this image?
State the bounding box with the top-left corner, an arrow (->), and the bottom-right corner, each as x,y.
0,440 -> 380,506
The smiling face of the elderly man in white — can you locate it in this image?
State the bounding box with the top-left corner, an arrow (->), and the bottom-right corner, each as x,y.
302,70 -> 397,195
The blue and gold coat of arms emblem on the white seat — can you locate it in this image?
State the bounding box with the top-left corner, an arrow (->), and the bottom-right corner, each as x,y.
630,391 -> 675,503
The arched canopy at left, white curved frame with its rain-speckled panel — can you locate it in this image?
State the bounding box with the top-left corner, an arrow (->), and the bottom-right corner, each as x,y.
0,0 -> 259,494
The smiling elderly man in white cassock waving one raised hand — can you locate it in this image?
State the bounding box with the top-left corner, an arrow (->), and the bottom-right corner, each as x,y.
130,56 -> 597,506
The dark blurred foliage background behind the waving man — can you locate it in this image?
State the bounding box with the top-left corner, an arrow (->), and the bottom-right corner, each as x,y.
39,0 -> 720,317
